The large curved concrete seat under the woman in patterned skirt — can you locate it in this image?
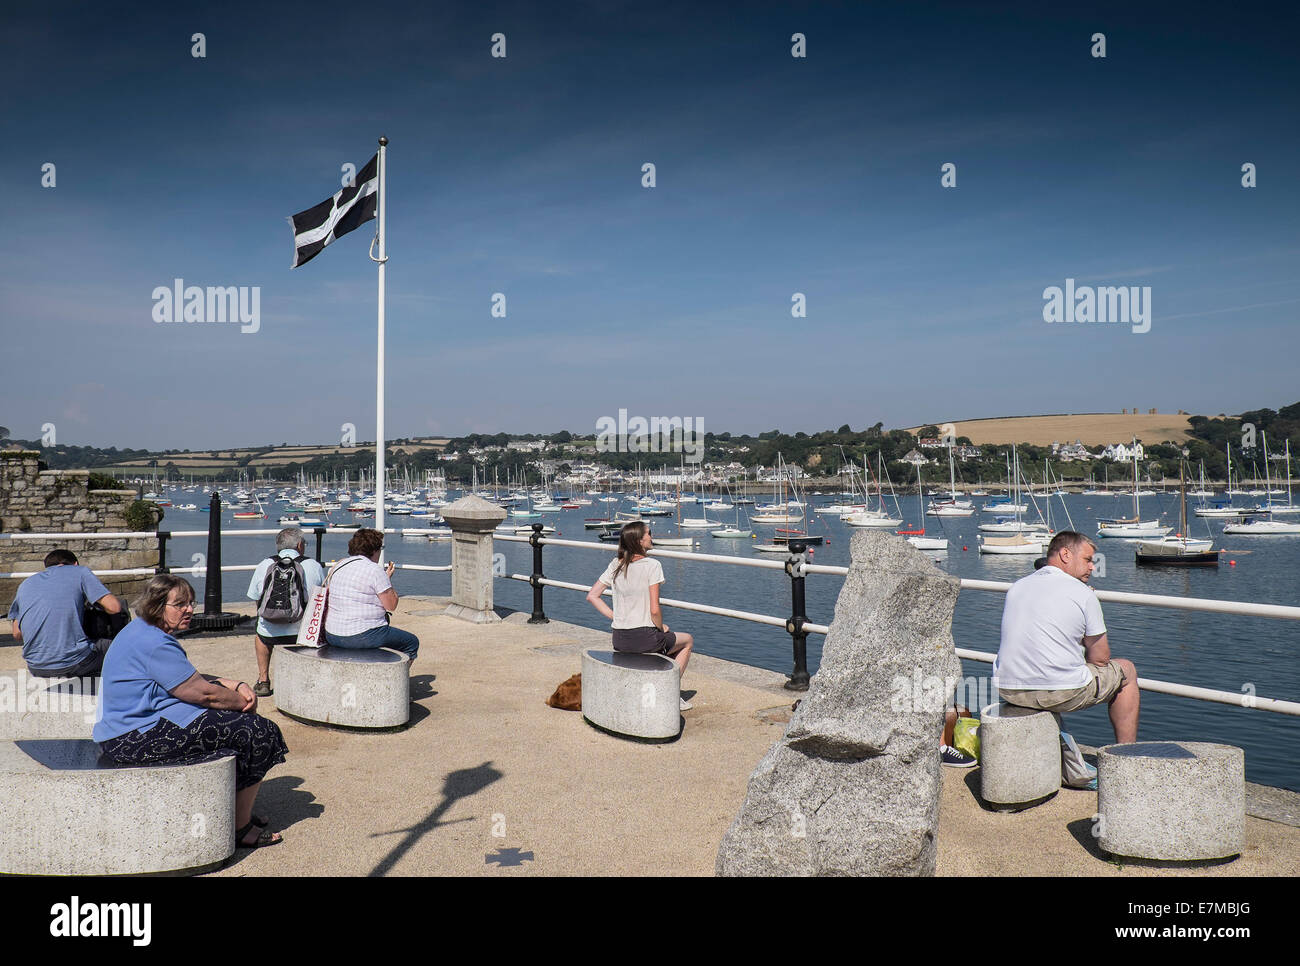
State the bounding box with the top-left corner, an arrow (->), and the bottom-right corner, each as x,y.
0,738 -> 235,875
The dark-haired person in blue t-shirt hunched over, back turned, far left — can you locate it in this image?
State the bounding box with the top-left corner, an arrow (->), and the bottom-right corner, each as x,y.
9,550 -> 122,677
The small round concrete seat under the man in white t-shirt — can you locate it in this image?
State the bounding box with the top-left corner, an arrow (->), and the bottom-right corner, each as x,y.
979,702 -> 1061,810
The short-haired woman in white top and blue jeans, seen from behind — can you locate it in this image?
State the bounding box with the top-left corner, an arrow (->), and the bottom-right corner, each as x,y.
325,527 -> 420,660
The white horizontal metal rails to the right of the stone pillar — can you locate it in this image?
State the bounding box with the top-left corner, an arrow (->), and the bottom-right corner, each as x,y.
495,534 -> 1300,716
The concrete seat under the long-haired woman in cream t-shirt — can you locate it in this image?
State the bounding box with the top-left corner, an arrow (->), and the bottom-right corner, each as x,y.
582,650 -> 681,738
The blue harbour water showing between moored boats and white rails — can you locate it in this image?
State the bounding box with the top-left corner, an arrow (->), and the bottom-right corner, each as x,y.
164,493 -> 1300,790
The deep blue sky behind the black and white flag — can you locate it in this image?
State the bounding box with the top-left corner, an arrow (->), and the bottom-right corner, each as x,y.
0,3 -> 1300,449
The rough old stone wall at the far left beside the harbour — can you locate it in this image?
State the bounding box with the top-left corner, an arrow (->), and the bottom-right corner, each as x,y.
0,450 -> 159,610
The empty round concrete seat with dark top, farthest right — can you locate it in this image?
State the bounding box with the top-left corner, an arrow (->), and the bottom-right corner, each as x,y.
1097,741 -> 1245,861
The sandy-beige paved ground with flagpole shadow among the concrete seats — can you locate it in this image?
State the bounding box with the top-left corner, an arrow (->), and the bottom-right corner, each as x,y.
0,597 -> 1300,876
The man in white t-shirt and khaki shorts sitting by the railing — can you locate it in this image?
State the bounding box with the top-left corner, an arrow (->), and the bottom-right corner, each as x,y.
993,530 -> 1139,744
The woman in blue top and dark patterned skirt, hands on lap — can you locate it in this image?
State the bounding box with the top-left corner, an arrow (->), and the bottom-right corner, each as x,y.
94,573 -> 289,849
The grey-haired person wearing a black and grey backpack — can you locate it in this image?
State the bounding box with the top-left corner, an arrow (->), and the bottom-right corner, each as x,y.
248,527 -> 325,698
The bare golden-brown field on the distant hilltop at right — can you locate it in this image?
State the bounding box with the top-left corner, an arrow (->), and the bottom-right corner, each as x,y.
907,412 -> 1191,449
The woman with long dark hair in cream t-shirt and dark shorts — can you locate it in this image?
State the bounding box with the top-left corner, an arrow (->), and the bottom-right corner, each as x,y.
586,520 -> 694,711
